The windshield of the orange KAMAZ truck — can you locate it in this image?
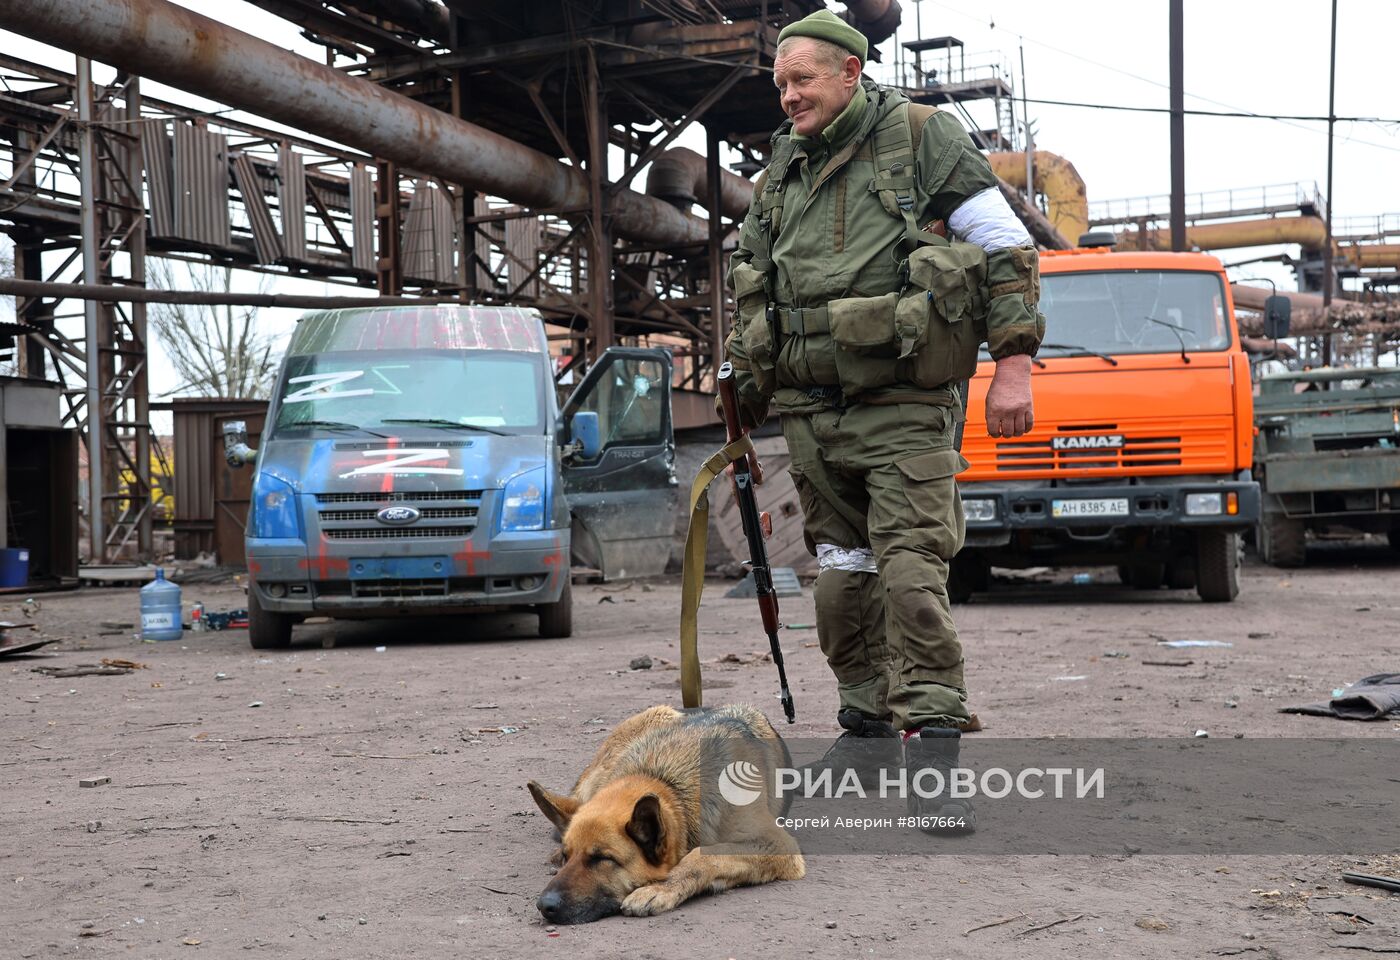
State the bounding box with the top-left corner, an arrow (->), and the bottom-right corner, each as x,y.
1040,270 -> 1231,355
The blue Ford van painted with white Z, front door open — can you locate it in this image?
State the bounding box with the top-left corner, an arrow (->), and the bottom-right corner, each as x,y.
224,305 -> 678,649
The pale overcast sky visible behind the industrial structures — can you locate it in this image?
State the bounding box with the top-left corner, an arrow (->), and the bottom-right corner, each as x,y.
0,0 -> 1400,405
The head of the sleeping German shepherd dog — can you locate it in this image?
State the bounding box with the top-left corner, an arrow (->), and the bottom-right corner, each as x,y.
529,777 -> 682,924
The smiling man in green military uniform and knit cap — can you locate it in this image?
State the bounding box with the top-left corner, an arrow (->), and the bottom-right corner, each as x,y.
725,10 -> 1044,834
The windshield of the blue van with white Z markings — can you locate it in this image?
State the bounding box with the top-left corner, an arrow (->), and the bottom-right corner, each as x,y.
276,350 -> 545,434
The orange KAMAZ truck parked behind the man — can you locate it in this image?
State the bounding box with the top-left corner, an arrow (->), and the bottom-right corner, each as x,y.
949,246 -> 1260,602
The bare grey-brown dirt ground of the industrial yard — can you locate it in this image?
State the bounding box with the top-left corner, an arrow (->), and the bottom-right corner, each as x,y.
0,544 -> 1400,960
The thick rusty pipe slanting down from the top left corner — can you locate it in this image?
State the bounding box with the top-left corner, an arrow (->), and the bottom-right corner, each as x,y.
0,0 -> 707,245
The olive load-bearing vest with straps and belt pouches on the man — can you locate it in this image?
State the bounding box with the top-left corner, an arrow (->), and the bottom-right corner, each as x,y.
734,90 -> 987,400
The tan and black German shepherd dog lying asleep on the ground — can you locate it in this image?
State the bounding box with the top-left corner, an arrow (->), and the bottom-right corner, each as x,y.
529,705 -> 806,924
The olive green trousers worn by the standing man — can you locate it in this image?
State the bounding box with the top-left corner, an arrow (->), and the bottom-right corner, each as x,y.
783,403 -> 969,730
